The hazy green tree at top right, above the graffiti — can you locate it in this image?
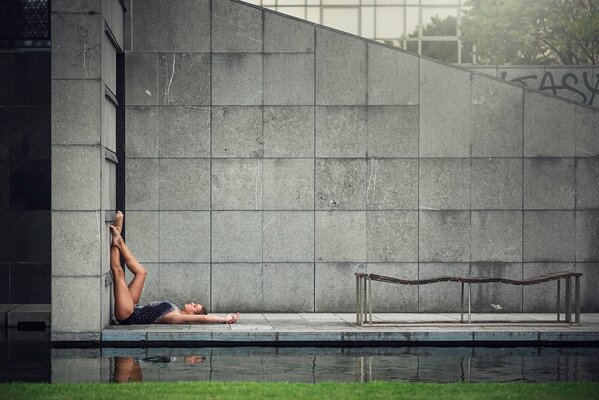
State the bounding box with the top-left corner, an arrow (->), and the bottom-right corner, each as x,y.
461,0 -> 599,65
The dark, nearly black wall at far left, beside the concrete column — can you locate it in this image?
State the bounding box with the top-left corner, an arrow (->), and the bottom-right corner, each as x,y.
0,49 -> 51,304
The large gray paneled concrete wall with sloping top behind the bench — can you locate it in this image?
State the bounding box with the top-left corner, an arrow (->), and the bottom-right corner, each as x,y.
125,0 -> 599,312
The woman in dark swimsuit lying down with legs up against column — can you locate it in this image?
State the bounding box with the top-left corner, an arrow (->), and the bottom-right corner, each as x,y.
110,211 -> 239,325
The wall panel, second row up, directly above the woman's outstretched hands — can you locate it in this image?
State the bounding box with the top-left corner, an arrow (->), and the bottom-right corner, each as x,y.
212,211 -> 262,264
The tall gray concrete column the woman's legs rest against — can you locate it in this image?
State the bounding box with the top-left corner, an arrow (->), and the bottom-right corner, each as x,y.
51,0 -> 123,341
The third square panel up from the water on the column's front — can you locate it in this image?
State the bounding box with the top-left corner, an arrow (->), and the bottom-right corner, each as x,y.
52,146 -> 104,210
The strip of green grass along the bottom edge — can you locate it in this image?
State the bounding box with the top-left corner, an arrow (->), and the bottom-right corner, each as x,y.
0,382 -> 599,400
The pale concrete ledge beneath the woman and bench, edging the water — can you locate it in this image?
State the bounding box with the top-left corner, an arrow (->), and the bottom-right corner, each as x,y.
101,313 -> 599,346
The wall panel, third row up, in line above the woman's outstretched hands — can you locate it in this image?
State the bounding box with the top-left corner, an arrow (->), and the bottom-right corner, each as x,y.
212,159 -> 263,210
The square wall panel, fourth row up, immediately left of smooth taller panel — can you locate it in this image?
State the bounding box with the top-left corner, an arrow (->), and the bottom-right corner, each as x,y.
366,106 -> 418,157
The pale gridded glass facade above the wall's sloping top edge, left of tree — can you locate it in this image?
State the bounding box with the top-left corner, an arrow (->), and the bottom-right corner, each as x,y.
247,0 -> 472,64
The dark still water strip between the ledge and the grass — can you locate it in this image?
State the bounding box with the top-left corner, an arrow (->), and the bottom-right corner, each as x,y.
0,342 -> 599,383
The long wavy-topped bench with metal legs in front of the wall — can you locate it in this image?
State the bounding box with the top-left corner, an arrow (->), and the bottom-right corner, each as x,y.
356,272 -> 582,325
